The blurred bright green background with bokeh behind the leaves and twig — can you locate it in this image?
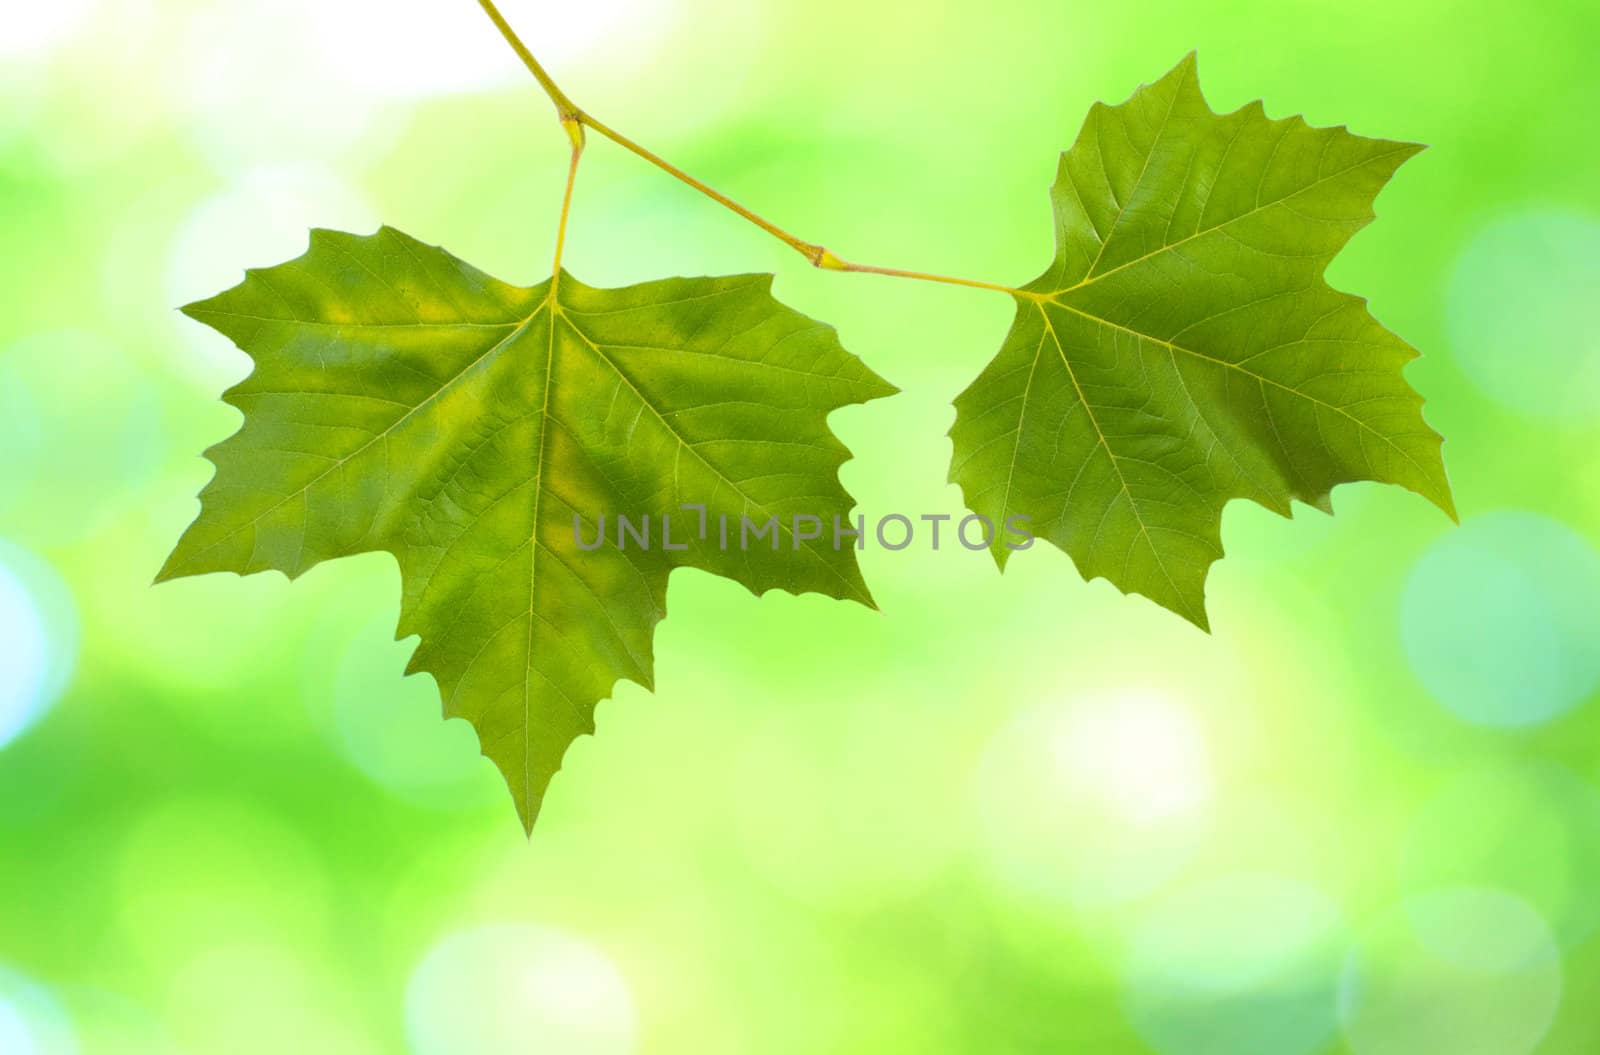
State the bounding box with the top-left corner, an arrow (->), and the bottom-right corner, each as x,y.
0,0 -> 1600,1055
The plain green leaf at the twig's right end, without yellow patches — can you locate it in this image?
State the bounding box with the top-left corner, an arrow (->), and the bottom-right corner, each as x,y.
950,54 -> 1454,628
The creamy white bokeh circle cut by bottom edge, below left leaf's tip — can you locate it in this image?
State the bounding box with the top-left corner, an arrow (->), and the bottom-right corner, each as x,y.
405,924 -> 635,1055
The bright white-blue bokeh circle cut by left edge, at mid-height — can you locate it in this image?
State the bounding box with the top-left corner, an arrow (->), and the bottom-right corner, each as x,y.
0,543 -> 78,749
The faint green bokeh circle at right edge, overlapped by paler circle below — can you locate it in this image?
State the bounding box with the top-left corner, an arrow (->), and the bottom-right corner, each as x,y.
1403,762 -> 1600,948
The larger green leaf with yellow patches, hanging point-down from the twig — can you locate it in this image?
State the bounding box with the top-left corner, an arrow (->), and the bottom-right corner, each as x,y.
160,229 -> 894,829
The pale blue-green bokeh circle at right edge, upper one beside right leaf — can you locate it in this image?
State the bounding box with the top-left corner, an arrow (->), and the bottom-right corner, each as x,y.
1450,210 -> 1600,421
